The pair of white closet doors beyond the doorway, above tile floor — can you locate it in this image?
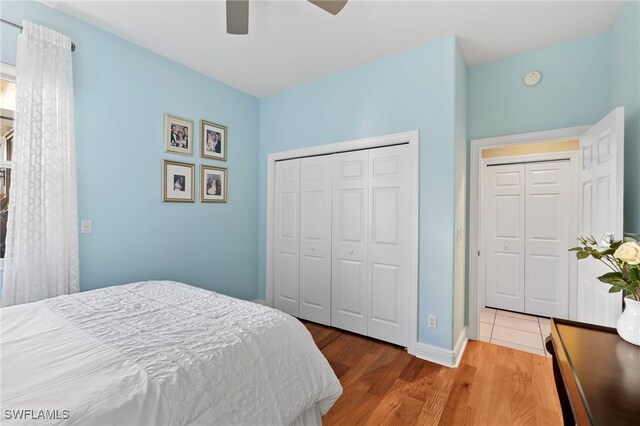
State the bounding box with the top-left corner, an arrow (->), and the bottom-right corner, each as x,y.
483,161 -> 571,318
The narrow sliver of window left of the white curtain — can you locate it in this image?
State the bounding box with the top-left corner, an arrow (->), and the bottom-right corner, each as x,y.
0,63 -> 16,266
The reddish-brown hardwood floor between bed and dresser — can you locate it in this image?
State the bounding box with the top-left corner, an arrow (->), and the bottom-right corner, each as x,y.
303,321 -> 562,426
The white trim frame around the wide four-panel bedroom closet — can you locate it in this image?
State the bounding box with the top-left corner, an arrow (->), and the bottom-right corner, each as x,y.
264,130 -> 420,354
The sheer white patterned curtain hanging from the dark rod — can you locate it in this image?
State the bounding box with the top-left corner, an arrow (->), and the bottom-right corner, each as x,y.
2,22 -> 79,306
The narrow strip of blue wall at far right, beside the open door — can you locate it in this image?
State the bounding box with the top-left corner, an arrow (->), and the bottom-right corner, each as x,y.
611,1 -> 640,234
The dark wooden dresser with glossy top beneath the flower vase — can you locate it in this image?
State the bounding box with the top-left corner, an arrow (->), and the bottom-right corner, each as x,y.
546,318 -> 640,426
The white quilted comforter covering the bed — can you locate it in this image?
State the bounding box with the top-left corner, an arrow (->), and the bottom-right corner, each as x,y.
0,281 -> 342,426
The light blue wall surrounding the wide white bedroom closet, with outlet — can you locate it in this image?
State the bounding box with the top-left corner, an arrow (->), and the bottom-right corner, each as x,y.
258,37 -> 455,348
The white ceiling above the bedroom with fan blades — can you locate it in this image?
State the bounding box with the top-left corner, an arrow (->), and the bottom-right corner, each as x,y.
45,0 -> 622,97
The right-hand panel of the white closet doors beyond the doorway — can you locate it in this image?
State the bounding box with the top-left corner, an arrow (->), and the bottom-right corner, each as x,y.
524,161 -> 572,318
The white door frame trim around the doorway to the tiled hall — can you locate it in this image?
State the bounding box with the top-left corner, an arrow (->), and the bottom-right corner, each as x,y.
467,126 -> 591,340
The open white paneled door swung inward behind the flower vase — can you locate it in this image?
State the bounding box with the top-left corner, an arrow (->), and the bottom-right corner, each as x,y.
577,107 -> 624,326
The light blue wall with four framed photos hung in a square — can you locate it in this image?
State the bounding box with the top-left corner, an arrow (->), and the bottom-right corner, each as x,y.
1,1 -> 259,299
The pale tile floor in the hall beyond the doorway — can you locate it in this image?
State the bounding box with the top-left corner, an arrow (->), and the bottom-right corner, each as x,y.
480,308 -> 550,357
